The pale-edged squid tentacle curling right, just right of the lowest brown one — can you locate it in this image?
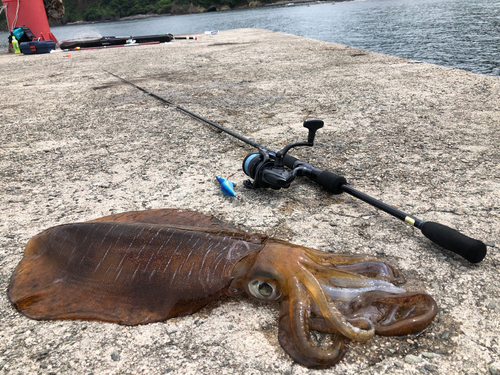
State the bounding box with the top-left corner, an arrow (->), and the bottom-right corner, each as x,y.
298,260 -> 375,341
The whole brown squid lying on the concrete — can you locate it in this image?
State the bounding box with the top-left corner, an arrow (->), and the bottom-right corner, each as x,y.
8,209 -> 437,368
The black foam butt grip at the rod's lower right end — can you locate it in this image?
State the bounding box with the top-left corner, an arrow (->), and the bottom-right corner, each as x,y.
421,221 -> 486,263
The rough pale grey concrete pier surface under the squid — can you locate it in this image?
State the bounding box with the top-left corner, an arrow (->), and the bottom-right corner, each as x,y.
0,29 -> 500,375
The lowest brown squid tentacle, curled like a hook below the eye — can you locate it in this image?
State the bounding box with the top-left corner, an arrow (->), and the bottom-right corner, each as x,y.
278,278 -> 347,368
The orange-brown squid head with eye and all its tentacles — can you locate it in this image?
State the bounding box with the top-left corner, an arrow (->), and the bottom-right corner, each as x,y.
228,239 -> 437,368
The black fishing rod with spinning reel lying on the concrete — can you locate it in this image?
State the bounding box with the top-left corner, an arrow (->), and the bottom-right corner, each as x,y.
105,70 -> 486,263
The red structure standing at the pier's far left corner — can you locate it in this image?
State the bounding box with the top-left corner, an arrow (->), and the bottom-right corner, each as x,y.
2,0 -> 58,43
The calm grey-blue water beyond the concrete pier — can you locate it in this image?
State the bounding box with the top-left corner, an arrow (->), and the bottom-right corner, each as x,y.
0,0 -> 500,76
